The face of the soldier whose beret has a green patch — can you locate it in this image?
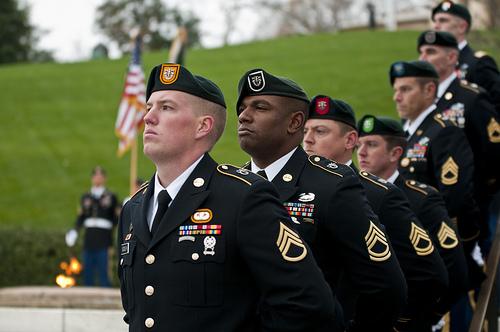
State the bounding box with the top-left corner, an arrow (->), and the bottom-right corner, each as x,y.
357,135 -> 391,176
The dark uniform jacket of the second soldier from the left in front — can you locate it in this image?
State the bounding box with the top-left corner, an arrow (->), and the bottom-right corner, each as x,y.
247,147 -> 406,331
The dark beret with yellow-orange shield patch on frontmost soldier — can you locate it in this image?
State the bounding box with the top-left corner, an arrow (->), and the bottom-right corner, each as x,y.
146,63 -> 226,107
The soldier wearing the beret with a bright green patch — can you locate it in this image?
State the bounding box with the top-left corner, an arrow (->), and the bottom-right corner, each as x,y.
357,115 -> 468,321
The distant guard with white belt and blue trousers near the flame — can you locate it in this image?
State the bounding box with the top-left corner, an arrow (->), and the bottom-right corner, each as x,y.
72,166 -> 121,287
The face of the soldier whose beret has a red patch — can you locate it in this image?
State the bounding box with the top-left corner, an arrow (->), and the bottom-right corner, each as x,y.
302,119 -> 348,162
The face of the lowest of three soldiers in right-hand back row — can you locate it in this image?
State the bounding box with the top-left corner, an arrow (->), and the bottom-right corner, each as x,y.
393,77 -> 426,120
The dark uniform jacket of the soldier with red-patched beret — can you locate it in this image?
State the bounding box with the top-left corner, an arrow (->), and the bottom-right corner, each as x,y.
348,166 -> 448,331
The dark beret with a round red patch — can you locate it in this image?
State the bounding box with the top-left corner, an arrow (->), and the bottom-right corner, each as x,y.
309,95 -> 356,128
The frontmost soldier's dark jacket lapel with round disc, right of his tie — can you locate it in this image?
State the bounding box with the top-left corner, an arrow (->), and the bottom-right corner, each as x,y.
146,154 -> 213,248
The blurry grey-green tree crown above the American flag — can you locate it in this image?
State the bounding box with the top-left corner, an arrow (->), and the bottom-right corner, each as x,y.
96,0 -> 200,52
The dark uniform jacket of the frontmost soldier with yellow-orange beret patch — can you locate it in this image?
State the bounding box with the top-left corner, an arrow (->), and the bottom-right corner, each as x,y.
118,155 -> 336,332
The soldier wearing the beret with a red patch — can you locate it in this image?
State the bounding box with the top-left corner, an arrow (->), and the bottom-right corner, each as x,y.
303,95 -> 448,332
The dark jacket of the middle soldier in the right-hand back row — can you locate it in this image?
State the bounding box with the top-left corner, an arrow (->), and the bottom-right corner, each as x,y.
436,78 -> 500,235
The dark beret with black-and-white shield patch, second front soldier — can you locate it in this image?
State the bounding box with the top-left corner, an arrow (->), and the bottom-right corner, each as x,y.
236,68 -> 309,112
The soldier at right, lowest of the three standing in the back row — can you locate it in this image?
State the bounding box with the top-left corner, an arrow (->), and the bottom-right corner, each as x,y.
390,61 -> 479,256
